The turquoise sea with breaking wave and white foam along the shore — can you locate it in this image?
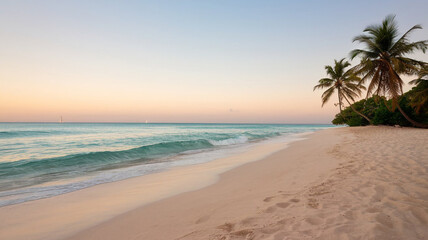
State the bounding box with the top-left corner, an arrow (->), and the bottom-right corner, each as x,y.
0,123 -> 333,206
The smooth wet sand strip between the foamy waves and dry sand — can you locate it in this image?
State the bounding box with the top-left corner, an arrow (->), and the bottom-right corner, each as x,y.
0,131 -> 308,239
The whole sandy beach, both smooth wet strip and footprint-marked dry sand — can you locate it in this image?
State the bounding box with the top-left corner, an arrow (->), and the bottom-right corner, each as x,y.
0,127 -> 428,240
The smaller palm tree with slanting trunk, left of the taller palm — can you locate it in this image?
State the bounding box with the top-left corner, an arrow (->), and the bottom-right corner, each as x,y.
314,58 -> 371,122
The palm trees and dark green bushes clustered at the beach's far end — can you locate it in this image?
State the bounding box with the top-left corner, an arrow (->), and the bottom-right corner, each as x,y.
314,16 -> 428,127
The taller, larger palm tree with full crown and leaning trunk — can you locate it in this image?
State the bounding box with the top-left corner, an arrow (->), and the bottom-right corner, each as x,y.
350,15 -> 428,127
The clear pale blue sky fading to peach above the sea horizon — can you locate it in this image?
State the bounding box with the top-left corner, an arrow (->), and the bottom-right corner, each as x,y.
0,0 -> 428,123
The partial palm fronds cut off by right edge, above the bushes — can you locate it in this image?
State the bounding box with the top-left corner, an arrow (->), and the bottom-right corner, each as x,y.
409,66 -> 428,114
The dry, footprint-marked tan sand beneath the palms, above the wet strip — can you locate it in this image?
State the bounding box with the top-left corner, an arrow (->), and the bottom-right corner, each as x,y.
0,127 -> 428,240
